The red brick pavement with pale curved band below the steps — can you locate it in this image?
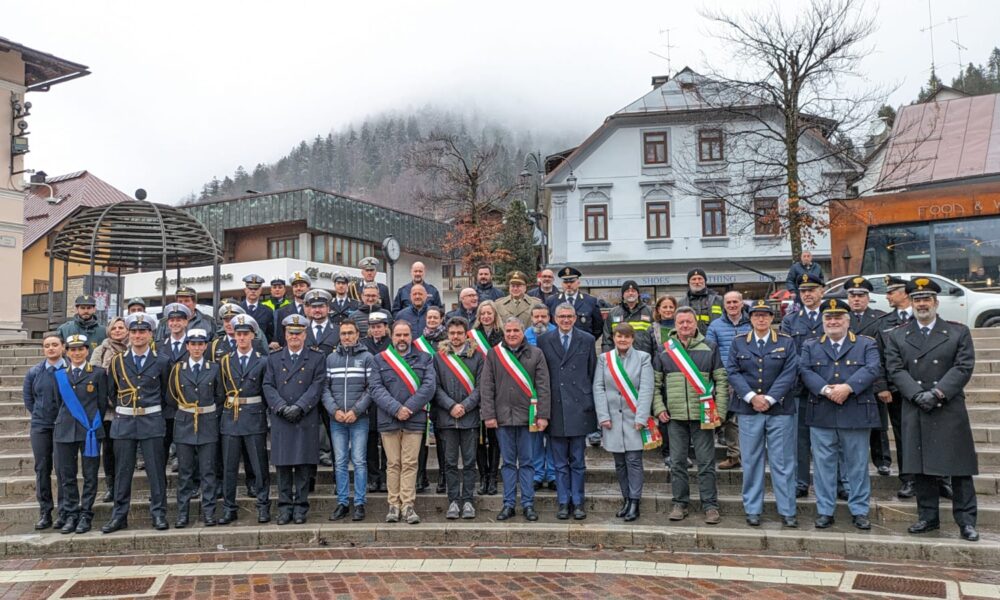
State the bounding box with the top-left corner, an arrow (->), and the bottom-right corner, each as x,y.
0,546 -> 1000,600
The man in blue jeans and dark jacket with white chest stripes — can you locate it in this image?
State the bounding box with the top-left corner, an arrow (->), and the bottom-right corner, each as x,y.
323,320 -> 375,521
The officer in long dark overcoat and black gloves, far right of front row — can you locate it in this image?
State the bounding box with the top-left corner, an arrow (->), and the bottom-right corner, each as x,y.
884,277 -> 979,542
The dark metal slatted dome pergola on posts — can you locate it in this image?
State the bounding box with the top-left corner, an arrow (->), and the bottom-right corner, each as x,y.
49,190 -> 223,322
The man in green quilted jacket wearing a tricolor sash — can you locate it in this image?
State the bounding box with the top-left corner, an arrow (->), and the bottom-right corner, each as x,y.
653,307 -> 729,525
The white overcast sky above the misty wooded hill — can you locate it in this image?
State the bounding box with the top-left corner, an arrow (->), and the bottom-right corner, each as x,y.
7,0 -> 1000,202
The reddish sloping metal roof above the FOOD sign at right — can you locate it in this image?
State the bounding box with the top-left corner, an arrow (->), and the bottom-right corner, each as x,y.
876,94 -> 1000,191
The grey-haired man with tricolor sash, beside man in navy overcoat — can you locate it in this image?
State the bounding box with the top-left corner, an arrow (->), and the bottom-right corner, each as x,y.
480,317 -> 551,521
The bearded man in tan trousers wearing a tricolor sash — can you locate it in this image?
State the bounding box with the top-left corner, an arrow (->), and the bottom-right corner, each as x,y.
369,320 -> 437,525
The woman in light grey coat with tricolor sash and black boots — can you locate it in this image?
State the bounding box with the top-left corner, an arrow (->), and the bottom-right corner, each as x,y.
594,323 -> 653,521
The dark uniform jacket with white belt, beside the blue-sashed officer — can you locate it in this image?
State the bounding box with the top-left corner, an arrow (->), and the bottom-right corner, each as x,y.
108,350 -> 170,440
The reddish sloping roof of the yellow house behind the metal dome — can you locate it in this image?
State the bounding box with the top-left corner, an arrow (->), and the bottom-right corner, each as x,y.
24,171 -> 131,249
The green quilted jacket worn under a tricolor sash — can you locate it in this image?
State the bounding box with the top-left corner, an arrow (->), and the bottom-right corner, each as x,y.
653,331 -> 729,421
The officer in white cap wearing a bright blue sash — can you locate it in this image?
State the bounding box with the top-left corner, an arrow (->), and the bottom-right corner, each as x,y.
52,335 -> 108,533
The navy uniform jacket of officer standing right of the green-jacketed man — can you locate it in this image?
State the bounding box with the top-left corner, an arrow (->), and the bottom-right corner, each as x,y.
720,330 -> 799,415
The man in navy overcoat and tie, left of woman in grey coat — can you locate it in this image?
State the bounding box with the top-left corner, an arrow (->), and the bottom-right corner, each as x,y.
530,302 -> 597,521
